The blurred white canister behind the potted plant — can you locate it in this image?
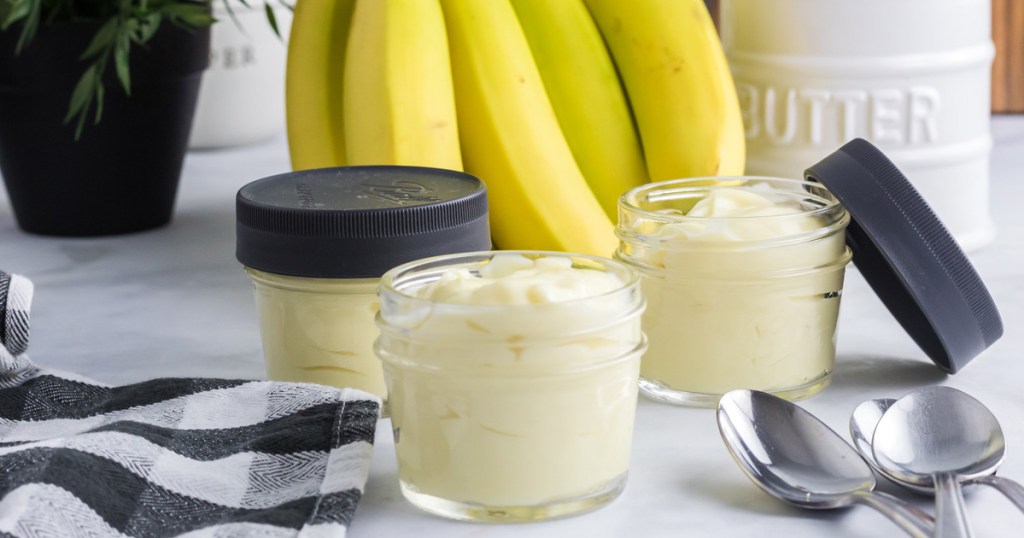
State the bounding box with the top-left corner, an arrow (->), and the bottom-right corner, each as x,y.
188,2 -> 292,149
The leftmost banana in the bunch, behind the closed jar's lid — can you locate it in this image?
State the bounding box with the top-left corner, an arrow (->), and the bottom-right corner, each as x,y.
285,0 -> 355,170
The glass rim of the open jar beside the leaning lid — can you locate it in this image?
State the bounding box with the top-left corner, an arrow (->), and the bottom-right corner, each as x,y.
618,175 -> 846,222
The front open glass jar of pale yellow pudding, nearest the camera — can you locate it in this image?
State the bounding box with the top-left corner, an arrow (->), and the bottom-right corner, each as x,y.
376,251 -> 646,522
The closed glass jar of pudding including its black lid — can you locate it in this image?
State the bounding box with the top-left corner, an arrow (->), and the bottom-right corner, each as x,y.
237,166 -> 490,407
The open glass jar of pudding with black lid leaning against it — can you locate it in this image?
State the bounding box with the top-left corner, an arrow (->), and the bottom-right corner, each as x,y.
615,177 -> 851,407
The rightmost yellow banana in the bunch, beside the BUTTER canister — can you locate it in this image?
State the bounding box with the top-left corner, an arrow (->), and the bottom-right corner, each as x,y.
586,0 -> 745,181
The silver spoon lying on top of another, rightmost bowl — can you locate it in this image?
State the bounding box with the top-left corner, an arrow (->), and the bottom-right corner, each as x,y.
871,386 -> 1006,538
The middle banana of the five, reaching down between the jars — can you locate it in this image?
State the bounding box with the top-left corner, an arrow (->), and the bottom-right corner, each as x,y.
441,0 -> 616,256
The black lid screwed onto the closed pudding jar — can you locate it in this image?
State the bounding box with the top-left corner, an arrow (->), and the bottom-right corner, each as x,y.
236,166 -> 490,278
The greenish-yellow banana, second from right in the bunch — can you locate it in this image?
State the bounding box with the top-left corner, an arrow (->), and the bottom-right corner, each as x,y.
512,0 -> 647,219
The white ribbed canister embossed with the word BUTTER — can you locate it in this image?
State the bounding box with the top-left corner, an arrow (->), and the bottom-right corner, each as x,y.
720,0 -> 995,250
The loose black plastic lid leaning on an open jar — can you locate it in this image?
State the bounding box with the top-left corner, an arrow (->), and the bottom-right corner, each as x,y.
805,138 -> 1002,373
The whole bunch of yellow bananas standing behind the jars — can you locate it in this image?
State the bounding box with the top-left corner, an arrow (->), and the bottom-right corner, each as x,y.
286,0 -> 744,256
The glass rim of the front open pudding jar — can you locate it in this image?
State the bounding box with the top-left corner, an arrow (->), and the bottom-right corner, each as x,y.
380,250 -> 640,311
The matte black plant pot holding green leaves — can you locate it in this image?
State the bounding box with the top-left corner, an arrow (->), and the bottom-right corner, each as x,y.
0,23 -> 210,236
